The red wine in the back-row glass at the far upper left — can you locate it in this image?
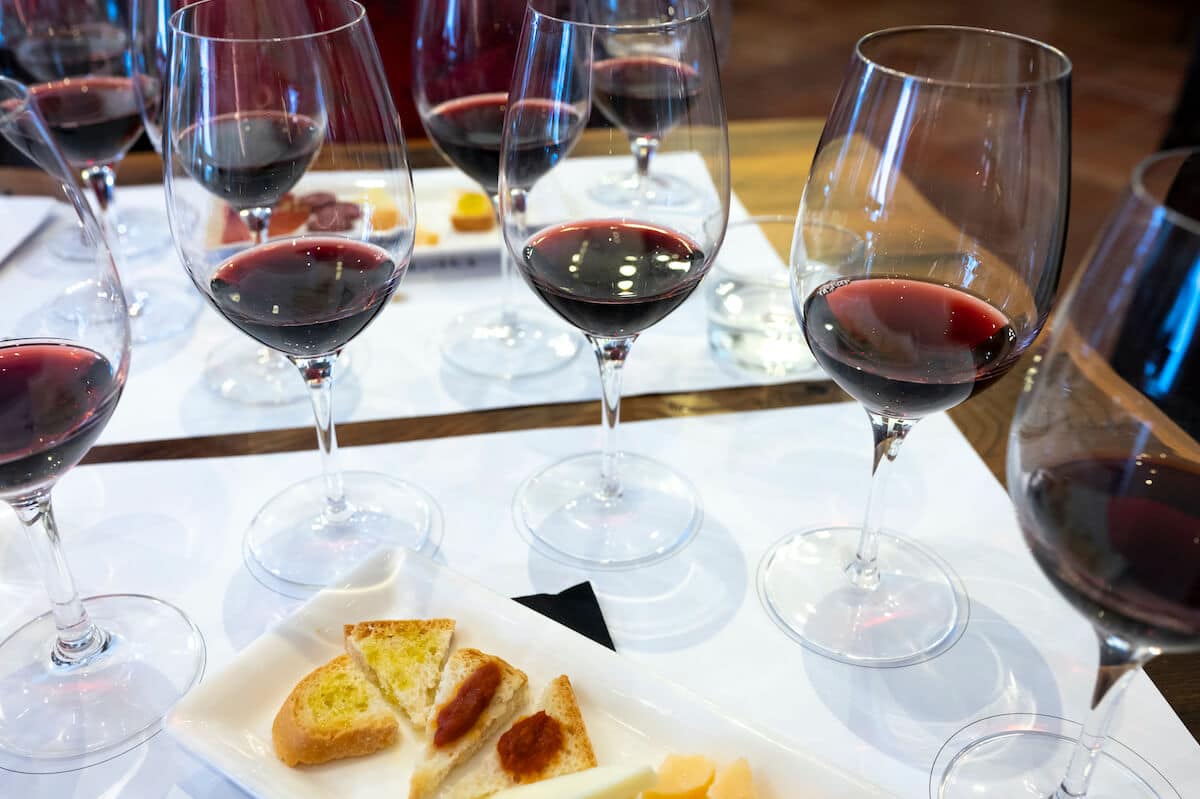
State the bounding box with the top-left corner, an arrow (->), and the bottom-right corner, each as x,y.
30,77 -> 142,167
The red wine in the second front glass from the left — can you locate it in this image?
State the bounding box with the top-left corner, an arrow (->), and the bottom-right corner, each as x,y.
210,236 -> 404,358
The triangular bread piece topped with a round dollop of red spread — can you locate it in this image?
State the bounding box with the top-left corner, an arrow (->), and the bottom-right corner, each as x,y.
449,674 -> 596,799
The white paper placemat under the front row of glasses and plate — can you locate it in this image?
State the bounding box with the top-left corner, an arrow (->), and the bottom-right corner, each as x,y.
0,404 -> 1200,799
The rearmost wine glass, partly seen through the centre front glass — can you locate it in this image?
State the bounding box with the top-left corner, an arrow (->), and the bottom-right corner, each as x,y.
588,0 -> 700,208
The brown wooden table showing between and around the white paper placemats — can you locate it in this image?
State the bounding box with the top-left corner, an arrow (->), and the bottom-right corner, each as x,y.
0,119 -> 1200,739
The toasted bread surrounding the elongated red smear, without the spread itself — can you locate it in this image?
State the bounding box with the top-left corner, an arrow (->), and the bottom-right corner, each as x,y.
408,649 -> 529,799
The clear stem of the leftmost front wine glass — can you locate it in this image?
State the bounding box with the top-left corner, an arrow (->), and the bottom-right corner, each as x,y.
12,491 -> 109,667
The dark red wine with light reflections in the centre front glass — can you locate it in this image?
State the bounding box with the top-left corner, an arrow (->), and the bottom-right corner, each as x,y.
521,220 -> 708,338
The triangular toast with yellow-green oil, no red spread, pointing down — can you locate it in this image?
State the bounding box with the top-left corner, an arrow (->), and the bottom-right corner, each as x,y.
346,619 -> 454,727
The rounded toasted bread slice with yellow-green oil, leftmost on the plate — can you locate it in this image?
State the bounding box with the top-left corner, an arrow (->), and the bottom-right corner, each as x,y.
271,655 -> 400,765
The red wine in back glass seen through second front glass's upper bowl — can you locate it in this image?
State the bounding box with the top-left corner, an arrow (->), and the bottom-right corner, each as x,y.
175,110 -> 324,210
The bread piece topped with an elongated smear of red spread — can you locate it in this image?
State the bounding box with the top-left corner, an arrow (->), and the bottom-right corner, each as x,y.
408,649 -> 529,799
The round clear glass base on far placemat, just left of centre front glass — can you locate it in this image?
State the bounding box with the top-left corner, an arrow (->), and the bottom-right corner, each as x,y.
442,306 -> 581,380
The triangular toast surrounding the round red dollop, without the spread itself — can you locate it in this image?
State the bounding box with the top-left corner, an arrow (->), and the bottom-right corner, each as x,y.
449,674 -> 596,799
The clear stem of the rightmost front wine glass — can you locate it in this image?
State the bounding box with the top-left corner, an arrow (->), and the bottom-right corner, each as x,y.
1054,632 -> 1158,799
